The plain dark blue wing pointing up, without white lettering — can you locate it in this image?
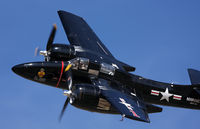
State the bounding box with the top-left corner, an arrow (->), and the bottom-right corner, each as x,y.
58,11 -> 114,58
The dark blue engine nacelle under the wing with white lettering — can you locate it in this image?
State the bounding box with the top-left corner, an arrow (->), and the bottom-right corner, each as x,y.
72,84 -> 119,114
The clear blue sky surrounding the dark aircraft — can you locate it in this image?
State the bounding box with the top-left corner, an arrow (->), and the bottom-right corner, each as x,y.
0,0 -> 200,129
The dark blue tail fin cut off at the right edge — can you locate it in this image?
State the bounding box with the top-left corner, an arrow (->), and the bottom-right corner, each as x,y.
188,69 -> 200,85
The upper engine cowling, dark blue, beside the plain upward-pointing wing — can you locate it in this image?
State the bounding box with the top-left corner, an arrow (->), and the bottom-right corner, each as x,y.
49,44 -> 76,61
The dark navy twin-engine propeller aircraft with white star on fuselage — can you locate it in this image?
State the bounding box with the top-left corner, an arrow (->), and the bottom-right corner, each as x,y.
12,11 -> 200,123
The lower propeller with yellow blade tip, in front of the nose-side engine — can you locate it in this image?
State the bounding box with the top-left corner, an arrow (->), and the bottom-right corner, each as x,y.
59,63 -> 73,121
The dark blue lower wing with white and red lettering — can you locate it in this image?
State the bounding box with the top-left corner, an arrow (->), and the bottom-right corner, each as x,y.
94,79 -> 150,123
